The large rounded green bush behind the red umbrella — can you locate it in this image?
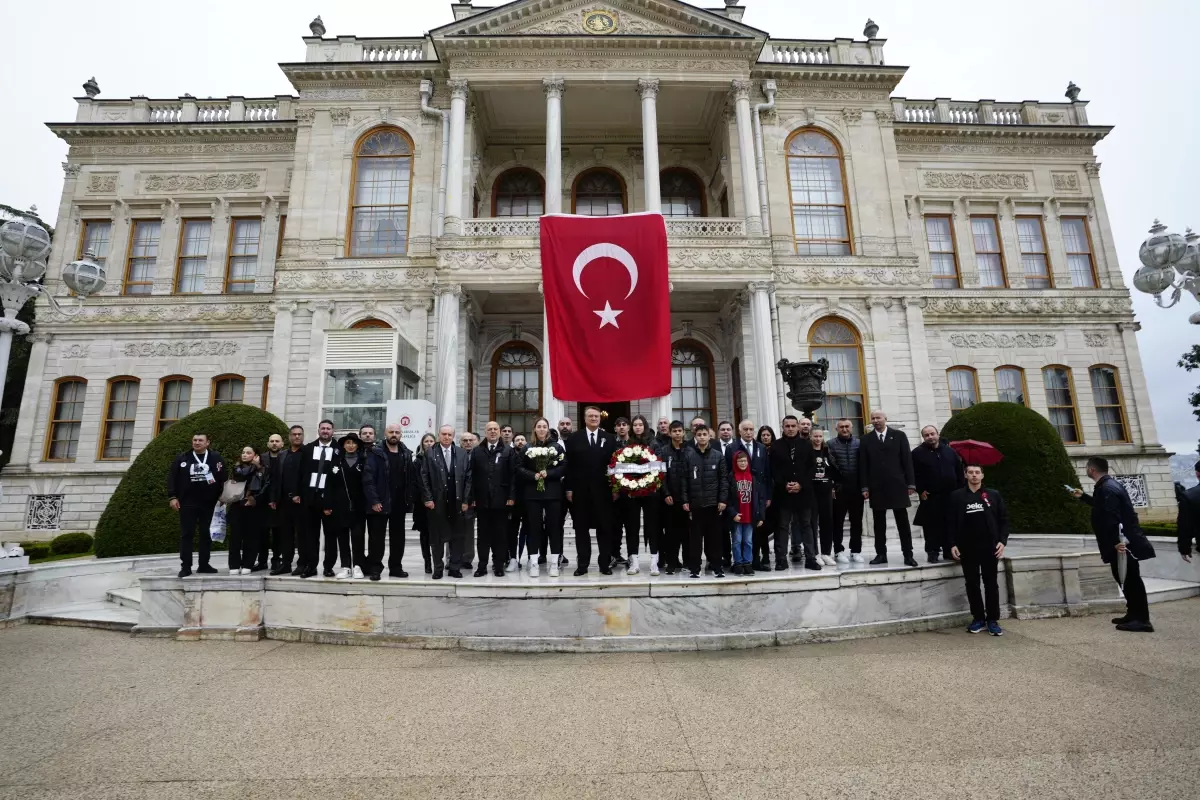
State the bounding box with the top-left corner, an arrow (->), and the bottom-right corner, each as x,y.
942,403 -> 1091,535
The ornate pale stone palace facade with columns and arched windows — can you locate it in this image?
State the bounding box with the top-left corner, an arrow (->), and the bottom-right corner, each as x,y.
0,0 -> 1171,535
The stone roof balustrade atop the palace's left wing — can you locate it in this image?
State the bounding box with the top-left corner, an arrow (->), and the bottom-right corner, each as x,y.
76,95 -> 296,125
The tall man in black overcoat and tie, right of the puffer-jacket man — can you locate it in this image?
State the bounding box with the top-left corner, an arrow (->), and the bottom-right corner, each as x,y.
858,411 -> 917,566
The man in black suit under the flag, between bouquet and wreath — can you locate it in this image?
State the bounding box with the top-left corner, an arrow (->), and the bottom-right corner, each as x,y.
565,405 -> 617,576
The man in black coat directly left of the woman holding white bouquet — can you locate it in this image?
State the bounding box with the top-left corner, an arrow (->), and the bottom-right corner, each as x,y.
467,420 -> 516,578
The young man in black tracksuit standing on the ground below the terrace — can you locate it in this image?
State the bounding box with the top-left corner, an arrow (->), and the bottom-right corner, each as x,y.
946,464 -> 1008,636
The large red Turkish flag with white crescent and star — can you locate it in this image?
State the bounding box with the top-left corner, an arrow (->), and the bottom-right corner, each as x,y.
541,213 -> 671,403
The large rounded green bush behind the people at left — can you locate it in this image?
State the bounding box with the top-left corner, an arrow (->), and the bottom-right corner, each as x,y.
96,404 -> 288,558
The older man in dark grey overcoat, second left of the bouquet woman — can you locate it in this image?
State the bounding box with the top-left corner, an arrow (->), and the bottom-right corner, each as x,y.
420,425 -> 470,581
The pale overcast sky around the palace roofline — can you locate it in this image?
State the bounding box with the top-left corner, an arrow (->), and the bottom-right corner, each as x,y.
0,0 -> 1200,452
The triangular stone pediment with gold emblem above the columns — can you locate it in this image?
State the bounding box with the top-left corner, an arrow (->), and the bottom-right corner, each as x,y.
433,0 -> 763,38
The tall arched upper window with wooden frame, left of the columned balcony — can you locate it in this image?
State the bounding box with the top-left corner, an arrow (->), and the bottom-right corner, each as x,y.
348,128 -> 413,255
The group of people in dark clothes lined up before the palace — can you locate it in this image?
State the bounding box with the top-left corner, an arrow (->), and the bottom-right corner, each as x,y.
167,407 -> 1171,636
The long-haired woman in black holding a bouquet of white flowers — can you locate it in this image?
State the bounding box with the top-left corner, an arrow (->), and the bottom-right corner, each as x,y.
517,417 -> 566,578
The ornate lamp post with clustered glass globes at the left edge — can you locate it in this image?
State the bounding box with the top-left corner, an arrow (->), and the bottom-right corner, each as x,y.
0,219 -> 104,387
